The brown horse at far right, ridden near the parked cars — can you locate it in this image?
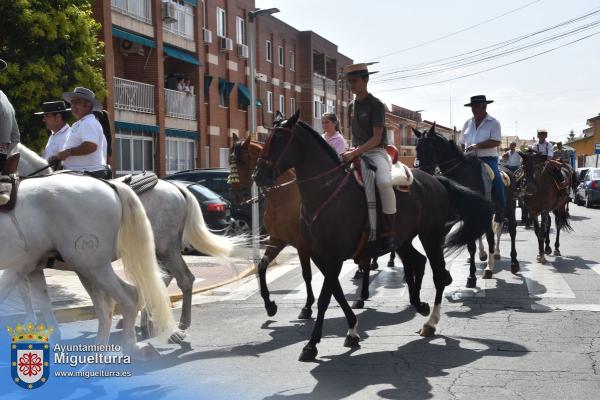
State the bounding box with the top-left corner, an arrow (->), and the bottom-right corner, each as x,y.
519,151 -> 573,263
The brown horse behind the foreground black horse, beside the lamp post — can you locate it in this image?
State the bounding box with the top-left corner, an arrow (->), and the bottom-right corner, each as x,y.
229,135 -> 315,319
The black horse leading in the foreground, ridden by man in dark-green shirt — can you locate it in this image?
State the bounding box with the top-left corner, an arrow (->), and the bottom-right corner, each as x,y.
254,112 -> 492,361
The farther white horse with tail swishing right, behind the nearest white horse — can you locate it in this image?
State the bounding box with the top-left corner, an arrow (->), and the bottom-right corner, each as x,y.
15,144 -> 244,335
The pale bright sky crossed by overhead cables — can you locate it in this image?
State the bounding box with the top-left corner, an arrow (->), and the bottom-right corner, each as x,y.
256,0 -> 600,140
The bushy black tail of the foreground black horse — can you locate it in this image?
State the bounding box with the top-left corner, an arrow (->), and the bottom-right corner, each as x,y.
437,176 -> 493,253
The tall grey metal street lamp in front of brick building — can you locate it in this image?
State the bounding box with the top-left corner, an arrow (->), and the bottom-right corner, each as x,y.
248,8 -> 279,266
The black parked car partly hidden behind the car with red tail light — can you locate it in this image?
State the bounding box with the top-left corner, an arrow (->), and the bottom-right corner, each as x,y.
164,168 -> 264,233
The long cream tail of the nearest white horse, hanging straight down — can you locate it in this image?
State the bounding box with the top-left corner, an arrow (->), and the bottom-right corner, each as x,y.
112,181 -> 178,339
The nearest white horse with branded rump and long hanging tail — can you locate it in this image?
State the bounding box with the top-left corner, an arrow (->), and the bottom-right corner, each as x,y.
0,164 -> 178,358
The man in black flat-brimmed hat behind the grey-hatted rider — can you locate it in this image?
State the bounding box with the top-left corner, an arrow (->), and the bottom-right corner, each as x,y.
34,101 -> 71,162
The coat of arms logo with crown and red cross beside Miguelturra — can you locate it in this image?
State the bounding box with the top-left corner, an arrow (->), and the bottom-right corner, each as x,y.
8,323 -> 53,389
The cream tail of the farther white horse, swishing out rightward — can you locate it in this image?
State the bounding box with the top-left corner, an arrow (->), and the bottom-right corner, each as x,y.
178,186 -> 246,257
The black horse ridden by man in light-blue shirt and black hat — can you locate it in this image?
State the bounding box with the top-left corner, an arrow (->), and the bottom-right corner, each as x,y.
413,124 -> 519,288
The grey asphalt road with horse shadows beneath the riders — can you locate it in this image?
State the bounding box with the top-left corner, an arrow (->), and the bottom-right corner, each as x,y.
0,205 -> 600,400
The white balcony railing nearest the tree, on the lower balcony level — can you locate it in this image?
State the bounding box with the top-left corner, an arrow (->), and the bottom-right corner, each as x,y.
114,78 -> 154,114
